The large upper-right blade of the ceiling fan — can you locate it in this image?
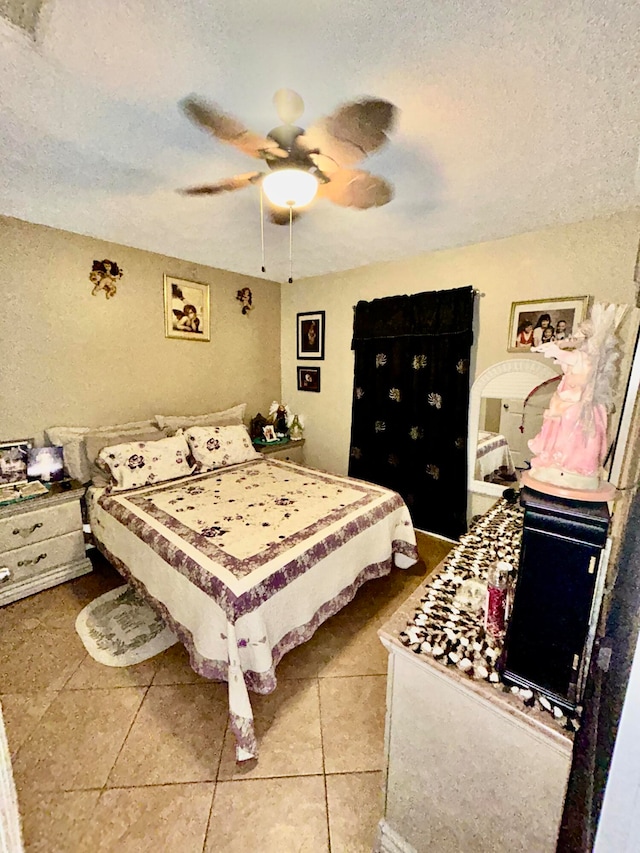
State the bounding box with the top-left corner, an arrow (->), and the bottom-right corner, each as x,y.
300,98 -> 398,171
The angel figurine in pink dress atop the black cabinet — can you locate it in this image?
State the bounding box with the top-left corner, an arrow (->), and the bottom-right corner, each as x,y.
527,302 -> 626,492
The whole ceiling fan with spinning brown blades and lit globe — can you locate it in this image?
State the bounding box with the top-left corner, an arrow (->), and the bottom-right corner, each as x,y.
175,89 -> 397,225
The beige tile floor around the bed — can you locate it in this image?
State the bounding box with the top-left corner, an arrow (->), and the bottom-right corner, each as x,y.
0,536 -> 451,853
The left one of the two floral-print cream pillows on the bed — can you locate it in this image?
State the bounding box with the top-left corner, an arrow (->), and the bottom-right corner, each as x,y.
97,435 -> 193,492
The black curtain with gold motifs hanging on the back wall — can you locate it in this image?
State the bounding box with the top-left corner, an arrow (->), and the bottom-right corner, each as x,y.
349,287 -> 473,539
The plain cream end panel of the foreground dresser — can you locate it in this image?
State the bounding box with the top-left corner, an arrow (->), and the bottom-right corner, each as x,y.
375,570 -> 572,853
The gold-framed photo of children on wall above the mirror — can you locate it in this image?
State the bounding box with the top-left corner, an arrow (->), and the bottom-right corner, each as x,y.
507,296 -> 589,352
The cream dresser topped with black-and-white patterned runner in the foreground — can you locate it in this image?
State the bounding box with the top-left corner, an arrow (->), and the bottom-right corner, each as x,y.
376,498 -> 578,853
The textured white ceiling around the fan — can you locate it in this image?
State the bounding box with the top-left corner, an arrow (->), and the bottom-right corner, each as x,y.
0,0 -> 640,281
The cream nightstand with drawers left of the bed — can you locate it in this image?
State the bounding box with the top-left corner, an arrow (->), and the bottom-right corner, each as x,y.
0,483 -> 92,606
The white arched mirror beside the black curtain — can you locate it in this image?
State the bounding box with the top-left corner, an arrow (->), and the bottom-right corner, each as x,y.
468,358 -> 560,497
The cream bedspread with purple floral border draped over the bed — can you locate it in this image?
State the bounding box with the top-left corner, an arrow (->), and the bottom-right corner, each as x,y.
87,456 -> 417,760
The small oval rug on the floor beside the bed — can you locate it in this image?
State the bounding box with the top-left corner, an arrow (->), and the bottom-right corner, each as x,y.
76,584 -> 178,666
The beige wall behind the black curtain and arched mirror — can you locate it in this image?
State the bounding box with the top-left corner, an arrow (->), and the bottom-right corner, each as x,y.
282,210 -> 640,516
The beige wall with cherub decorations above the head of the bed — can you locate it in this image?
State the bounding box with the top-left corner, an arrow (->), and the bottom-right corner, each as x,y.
0,217 -> 280,439
